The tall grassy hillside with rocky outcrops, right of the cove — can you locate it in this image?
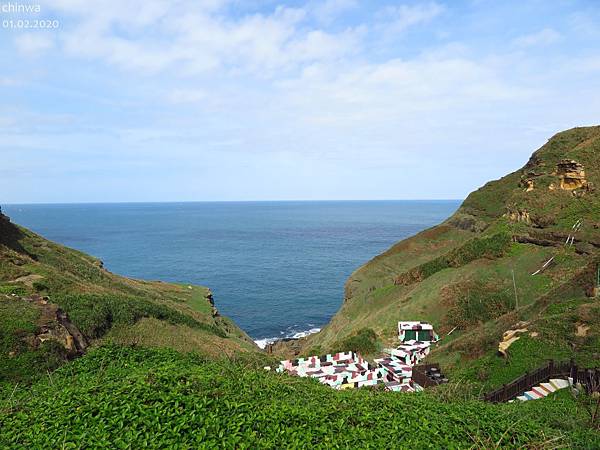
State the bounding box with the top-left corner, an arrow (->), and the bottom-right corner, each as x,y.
303,127 -> 600,385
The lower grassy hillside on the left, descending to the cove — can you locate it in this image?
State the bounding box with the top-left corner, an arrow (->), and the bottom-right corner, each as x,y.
0,216 -> 257,381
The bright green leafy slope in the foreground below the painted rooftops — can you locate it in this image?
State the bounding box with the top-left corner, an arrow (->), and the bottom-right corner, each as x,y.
0,347 -> 598,448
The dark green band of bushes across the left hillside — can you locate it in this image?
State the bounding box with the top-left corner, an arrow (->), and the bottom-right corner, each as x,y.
54,294 -> 227,339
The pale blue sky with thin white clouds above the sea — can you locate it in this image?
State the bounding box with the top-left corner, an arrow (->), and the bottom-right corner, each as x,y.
0,0 -> 600,203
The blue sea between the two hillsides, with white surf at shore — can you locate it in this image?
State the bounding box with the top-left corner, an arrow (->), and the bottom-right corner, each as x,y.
4,201 -> 460,345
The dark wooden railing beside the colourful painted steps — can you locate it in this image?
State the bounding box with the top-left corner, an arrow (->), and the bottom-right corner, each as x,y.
483,360 -> 600,403
